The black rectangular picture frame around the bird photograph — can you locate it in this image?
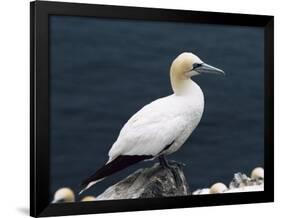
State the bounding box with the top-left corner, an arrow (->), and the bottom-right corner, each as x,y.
30,1 -> 274,217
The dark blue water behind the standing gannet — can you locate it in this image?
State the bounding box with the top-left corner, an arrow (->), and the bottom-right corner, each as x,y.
50,16 -> 264,195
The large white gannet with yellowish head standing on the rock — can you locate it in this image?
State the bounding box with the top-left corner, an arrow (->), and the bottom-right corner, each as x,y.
80,52 -> 224,194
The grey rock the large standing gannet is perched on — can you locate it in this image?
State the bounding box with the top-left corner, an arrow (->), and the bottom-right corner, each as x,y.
96,163 -> 191,200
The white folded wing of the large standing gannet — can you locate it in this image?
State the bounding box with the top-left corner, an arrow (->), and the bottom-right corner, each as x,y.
109,102 -> 186,160
